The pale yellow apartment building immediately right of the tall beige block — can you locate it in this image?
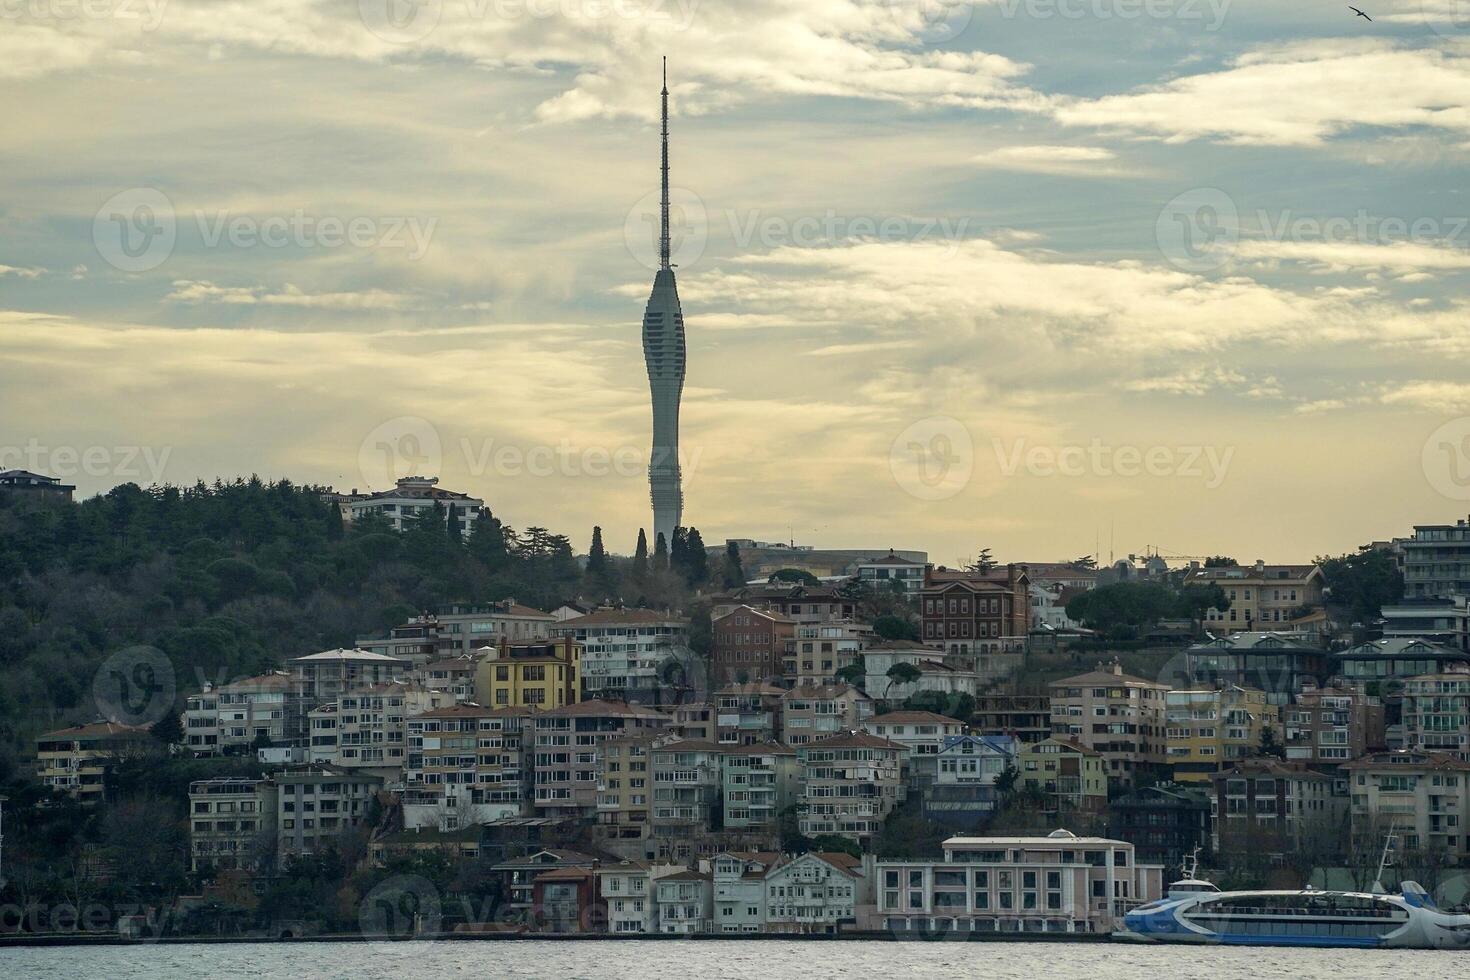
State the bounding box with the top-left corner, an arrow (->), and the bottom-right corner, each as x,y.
1164,686 -> 1282,783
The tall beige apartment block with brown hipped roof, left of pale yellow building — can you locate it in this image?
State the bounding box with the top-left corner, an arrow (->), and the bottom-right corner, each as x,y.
1048,661 -> 1169,786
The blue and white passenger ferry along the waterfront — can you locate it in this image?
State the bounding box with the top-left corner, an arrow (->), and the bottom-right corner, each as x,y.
1114,855 -> 1470,949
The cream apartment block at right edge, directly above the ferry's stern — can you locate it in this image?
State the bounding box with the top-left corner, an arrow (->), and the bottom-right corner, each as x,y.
1344,752 -> 1470,864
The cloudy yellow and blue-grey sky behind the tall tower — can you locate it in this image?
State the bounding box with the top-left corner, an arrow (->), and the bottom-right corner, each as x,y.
0,0 -> 1470,563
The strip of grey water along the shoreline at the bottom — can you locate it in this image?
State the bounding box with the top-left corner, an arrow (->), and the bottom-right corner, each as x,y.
0,940 -> 1470,980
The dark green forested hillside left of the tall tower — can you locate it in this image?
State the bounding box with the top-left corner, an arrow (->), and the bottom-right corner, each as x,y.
0,478 -> 602,783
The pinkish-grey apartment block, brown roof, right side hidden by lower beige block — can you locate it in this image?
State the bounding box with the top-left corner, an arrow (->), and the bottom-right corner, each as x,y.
531,701 -> 669,817
